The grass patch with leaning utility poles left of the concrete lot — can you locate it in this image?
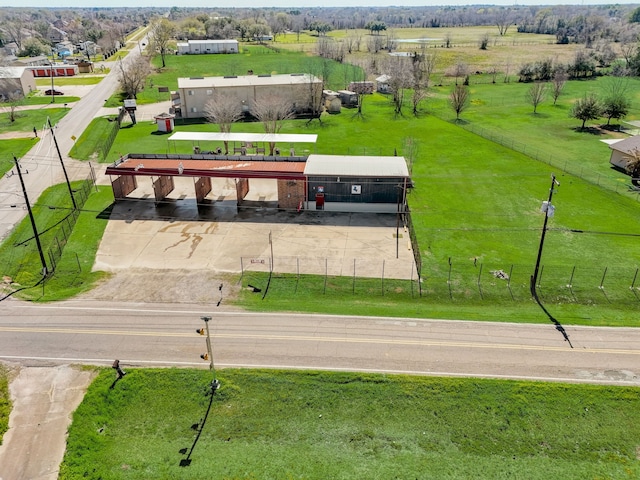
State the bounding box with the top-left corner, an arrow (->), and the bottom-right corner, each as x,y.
0,183 -> 113,301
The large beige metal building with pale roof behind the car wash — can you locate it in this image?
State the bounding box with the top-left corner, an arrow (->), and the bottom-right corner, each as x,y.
173,73 -> 322,118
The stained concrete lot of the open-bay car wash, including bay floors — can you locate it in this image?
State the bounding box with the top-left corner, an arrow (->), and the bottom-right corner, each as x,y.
94,178 -> 415,278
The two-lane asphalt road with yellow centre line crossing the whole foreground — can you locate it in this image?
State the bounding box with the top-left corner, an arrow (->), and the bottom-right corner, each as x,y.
0,300 -> 640,386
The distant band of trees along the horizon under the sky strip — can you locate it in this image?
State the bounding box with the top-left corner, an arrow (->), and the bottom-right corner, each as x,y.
0,4 -> 640,55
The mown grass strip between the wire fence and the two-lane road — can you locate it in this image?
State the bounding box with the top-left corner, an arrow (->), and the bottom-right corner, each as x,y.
234,272 -> 638,327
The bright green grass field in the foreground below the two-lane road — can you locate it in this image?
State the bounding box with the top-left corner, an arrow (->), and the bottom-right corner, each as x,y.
59,369 -> 640,480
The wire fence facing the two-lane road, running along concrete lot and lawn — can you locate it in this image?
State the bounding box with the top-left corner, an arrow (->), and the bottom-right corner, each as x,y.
240,253 -> 640,305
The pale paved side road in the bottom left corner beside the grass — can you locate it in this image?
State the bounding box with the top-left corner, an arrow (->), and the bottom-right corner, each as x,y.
0,365 -> 96,480
